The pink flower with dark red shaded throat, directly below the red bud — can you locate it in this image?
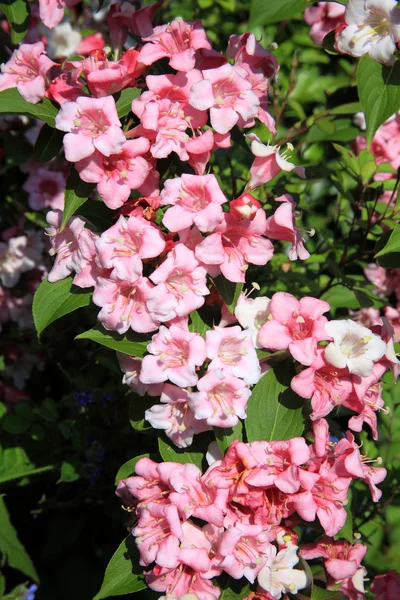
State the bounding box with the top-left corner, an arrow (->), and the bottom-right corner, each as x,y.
195,209 -> 274,283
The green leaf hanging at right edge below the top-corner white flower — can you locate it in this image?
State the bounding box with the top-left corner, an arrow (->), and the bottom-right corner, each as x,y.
357,54 -> 400,148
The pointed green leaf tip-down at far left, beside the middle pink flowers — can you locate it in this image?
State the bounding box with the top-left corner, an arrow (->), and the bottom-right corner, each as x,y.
32,277 -> 92,337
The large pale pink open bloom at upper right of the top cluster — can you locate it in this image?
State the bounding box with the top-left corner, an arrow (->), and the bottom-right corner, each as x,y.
189,63 -> 260,133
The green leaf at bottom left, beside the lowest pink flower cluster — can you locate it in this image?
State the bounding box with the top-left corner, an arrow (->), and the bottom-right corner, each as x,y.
93,535 -> 147,600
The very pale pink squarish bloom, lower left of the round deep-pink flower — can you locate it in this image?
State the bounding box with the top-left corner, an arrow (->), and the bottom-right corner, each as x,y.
206,325 -> 260,385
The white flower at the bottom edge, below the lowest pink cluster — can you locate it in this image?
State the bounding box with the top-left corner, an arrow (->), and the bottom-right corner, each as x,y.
258,544 -> 309,598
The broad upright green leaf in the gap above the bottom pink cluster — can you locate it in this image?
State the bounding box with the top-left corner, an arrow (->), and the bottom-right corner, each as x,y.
245,359 -> 304,442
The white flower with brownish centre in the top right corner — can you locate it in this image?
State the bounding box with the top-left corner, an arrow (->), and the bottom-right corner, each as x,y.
335,0 -> 400,66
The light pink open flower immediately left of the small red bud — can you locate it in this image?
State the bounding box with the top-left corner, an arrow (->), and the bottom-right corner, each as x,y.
160,174 -> 227,232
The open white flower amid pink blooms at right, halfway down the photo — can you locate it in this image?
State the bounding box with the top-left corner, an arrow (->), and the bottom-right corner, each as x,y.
325,319 -> 386,377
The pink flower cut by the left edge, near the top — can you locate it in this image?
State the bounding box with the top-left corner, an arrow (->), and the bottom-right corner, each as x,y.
0,42 -> 56,104
